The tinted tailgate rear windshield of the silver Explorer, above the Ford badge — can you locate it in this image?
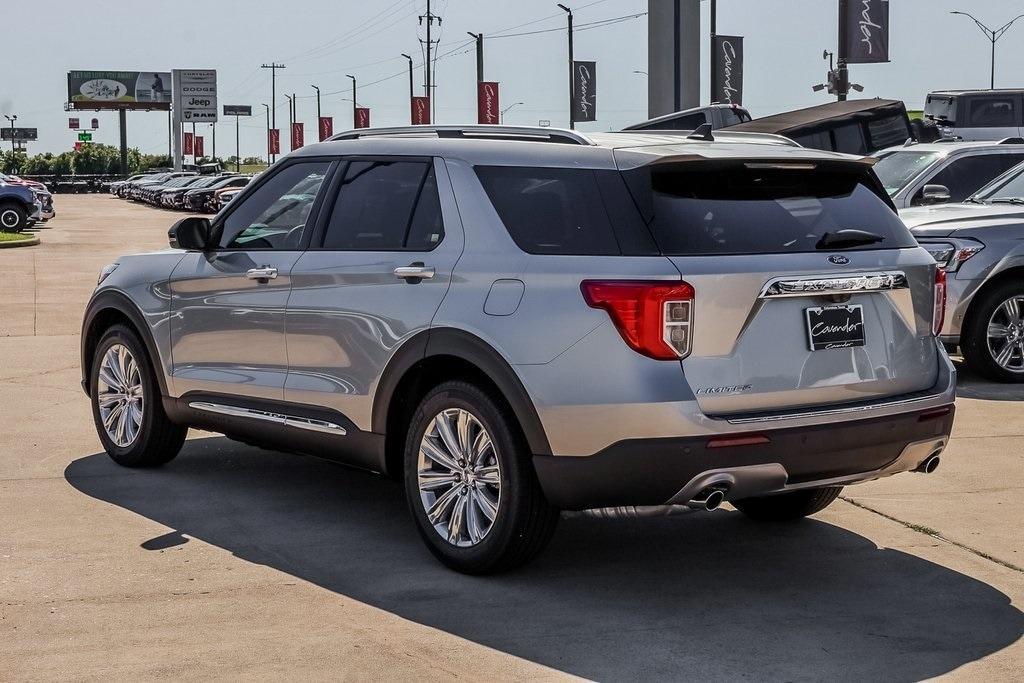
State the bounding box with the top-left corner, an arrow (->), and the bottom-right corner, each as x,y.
631,165 -> 915,256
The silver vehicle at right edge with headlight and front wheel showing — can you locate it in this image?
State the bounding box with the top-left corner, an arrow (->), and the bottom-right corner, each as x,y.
900,159 -> 1024,382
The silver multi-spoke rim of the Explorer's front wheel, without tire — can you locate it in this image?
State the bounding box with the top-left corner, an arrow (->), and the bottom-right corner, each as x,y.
96,344 -> 145,449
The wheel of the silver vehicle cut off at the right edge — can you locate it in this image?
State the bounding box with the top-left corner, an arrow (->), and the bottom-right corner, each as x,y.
961,282 -> 1024,382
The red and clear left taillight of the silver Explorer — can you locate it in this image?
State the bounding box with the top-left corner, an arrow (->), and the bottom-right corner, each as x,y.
580,280 -> 693,360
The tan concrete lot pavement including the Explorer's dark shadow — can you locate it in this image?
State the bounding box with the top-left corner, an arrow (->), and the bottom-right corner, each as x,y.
0,196 -> 1024,680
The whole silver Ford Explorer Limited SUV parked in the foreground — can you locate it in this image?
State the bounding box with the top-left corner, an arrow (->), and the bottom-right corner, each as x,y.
82,127 -> 955,572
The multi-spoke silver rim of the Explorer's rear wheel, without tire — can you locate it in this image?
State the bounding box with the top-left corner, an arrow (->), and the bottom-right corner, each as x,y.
417,408 -> 502,548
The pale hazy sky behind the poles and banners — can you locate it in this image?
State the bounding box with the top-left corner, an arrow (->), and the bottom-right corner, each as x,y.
6,0 -> 1024,156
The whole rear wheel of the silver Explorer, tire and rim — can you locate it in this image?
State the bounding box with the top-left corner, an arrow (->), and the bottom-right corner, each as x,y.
404,382 -> 558,573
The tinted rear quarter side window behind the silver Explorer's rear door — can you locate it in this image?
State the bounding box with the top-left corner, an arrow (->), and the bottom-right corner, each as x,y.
476,166 -> 621,255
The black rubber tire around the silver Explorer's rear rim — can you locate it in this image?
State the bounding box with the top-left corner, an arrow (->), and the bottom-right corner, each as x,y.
404,382 -> 559,574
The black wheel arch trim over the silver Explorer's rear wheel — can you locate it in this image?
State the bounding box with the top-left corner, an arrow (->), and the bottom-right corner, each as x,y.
371,328 -> 551,475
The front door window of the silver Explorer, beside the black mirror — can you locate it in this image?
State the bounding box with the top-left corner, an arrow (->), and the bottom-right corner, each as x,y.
220,162 -> 331,249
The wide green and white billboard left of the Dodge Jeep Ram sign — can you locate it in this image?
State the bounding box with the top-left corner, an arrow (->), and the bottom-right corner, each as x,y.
68,71 -> 171,112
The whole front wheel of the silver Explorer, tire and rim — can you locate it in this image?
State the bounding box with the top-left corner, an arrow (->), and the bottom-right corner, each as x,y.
89,325 -> 188,467
